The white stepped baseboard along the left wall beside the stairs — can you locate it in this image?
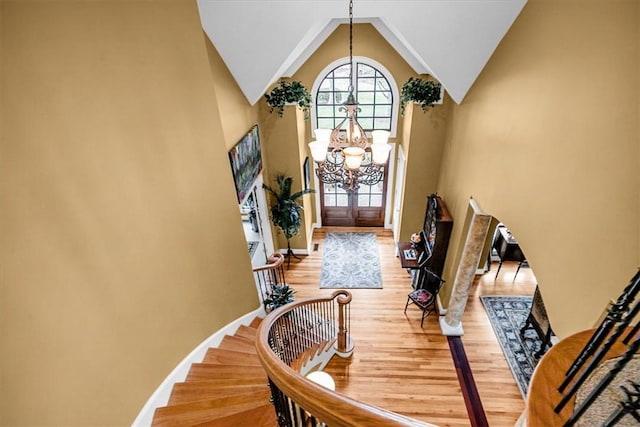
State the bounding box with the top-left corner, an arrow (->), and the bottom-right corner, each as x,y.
132,306 -> 266,427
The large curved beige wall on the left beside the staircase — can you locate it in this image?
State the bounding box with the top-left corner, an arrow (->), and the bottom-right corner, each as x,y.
0,0 -> 259,426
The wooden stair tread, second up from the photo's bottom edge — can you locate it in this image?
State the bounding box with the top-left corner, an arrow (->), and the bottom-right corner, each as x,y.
152,389 -> 271,426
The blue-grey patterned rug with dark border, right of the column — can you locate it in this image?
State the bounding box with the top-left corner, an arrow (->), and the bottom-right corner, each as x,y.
480,295 -> 542,397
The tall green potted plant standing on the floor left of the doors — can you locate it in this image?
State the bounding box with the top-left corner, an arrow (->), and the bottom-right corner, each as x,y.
262,174 -> 313,265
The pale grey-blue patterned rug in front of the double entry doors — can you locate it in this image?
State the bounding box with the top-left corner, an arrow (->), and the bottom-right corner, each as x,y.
320,233 -> 382,289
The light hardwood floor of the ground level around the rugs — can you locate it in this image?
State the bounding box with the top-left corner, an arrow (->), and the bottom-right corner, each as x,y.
286,227 -> 536,427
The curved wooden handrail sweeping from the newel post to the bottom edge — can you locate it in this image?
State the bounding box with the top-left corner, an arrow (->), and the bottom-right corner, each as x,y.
256,290 -> 433,427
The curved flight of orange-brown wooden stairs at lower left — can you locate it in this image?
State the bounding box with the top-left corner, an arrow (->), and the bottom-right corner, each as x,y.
152,318 -> 278,427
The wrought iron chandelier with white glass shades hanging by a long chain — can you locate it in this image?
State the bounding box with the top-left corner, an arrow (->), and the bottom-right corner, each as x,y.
309,0 -> 391,192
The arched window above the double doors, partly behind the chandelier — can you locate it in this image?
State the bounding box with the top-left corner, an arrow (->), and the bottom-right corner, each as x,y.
312,57 -> 399,137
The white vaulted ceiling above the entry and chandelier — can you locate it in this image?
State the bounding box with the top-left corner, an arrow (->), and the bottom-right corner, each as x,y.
198,0 -> 527,105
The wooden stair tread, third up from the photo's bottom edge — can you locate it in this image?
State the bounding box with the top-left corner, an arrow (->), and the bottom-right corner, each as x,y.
167,379 -> 269,406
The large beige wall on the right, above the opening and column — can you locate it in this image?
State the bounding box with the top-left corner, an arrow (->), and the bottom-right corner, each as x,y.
438,0 -> 640,336
